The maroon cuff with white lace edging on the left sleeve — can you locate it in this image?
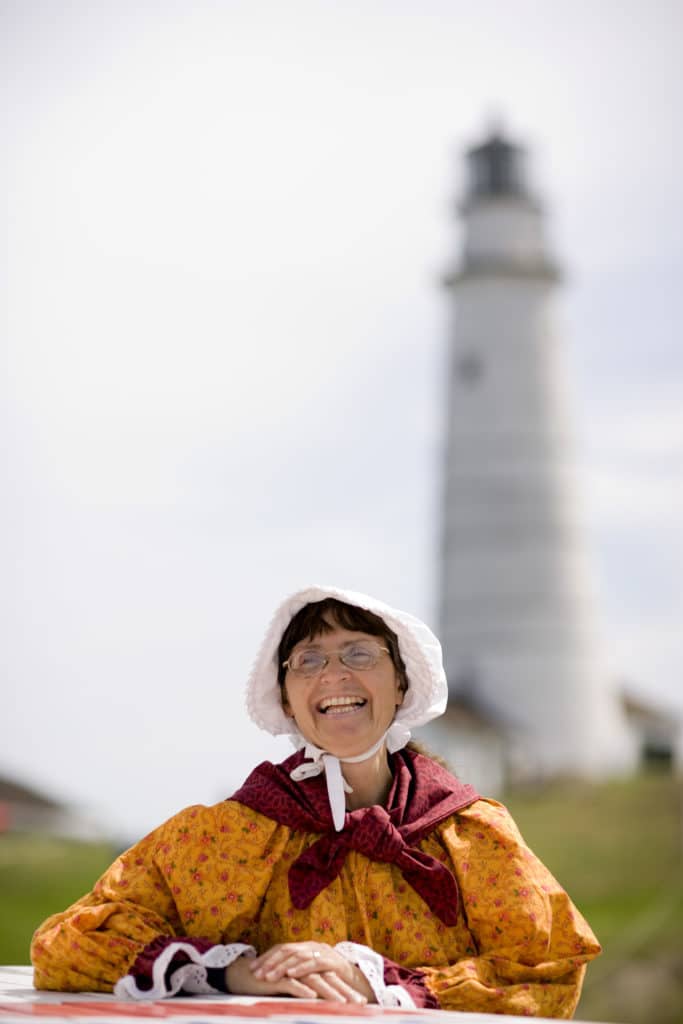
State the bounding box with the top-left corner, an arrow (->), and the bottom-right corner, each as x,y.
114,936 -> 256,999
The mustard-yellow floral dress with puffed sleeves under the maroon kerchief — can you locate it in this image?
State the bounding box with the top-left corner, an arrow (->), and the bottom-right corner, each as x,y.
32,753 -> 600,1018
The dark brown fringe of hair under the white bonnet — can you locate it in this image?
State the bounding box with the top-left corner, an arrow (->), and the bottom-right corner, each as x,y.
278,597 -> 408,693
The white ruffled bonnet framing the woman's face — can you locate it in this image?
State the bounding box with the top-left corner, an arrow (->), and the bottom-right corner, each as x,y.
247,586 -> 449,746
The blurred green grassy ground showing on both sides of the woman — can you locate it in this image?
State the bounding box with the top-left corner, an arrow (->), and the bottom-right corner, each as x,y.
0,776 -> 683,1024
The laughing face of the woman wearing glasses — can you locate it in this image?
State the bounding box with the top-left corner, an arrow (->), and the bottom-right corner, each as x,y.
283,626 -> 403,758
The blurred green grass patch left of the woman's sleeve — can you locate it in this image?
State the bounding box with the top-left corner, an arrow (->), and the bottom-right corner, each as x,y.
0,835 -> 115,964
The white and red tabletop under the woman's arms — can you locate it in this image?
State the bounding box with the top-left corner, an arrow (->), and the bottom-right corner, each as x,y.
0,967 -> 618,1024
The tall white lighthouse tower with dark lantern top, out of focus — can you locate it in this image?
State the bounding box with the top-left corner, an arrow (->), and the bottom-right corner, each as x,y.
437,133 -> 636,781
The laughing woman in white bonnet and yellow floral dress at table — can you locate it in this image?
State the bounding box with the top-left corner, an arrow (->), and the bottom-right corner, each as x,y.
32,587 -> 600,1018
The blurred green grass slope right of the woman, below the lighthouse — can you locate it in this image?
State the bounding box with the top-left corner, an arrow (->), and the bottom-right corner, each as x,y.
505,775 -> 683,1024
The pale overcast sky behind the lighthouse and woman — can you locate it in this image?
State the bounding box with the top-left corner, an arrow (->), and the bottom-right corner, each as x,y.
0,0 -> 683,839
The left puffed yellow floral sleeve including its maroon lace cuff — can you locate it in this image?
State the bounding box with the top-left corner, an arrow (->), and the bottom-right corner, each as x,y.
31,801 -> 287,998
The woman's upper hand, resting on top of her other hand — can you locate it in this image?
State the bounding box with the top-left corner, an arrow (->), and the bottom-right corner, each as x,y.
248,942 -> 375,1004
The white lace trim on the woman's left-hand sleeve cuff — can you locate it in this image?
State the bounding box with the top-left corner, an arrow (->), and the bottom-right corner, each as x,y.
114,940 -> 256,999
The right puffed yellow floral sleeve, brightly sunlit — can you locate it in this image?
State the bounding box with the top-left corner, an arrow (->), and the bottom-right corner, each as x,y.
422,800 -> 600,1018
